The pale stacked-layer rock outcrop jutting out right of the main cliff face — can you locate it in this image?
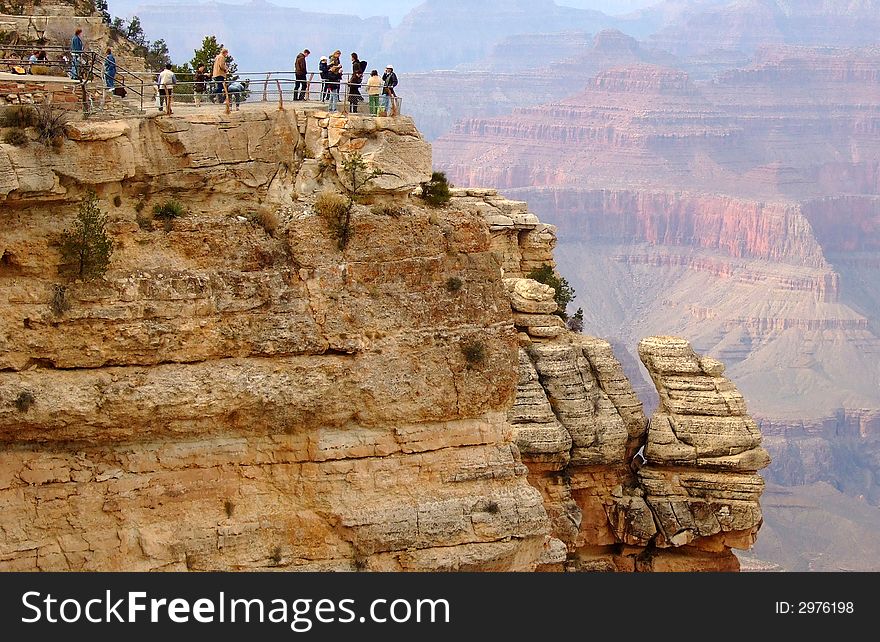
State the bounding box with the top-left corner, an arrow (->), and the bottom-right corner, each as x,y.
484,196 -> 770,572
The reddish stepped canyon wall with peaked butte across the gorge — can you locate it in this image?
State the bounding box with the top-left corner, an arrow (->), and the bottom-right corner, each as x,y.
435,47 -> 880,556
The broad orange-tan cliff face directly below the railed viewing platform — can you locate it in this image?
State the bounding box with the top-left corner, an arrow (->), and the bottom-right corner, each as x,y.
0,110 -> 549,570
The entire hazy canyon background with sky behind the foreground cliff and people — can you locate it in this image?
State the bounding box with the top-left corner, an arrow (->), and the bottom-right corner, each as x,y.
110,0 -> 880,570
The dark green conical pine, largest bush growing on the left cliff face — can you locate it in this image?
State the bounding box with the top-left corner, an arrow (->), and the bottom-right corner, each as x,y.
61,192 -> 113,281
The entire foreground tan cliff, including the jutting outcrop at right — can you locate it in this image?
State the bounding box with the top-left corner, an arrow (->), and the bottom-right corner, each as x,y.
0,105 -> 766,571
